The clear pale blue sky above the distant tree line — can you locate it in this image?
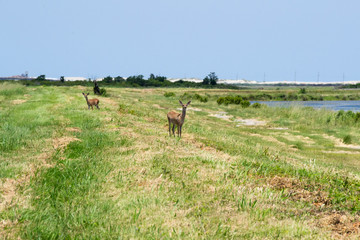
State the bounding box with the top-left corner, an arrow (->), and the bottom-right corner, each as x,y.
0,0 -> 360,82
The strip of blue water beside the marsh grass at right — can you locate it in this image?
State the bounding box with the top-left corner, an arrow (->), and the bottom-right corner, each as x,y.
251,101 -> 360,112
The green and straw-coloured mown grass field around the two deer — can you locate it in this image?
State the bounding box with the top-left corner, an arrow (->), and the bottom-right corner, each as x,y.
0,83 -> 360,239
